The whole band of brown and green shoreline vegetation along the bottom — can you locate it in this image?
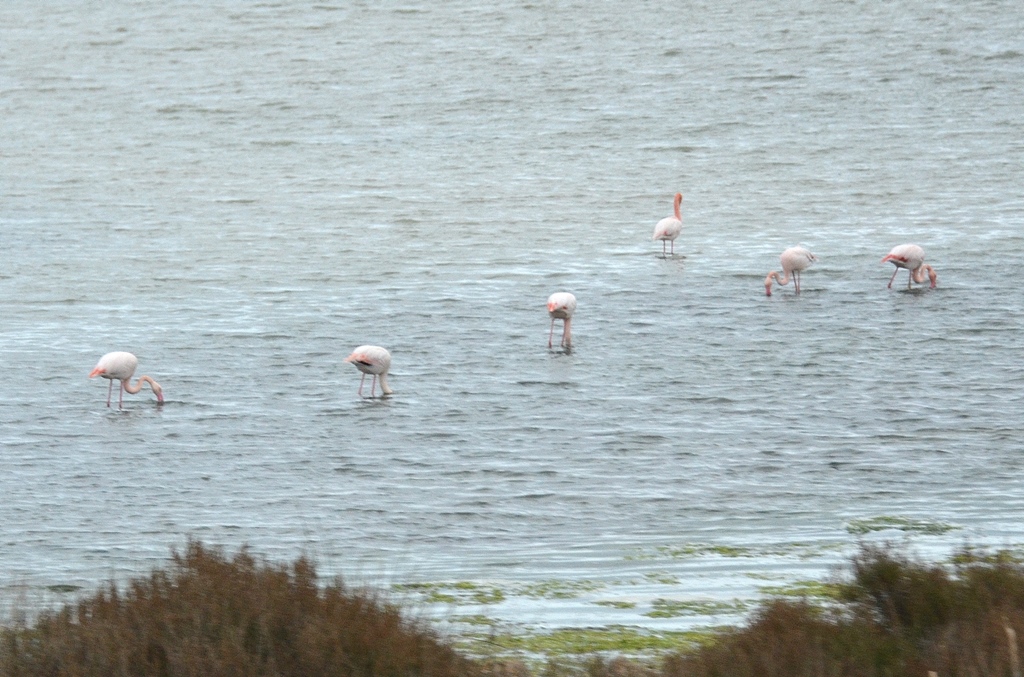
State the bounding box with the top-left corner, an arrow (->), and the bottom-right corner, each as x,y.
0,541 -> 1024,677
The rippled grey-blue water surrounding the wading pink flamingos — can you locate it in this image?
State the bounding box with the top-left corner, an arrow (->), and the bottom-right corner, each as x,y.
0,0 -> 1024,628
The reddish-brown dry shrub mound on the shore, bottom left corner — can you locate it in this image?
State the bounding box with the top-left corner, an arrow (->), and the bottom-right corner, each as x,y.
0,543 -> 479,677
